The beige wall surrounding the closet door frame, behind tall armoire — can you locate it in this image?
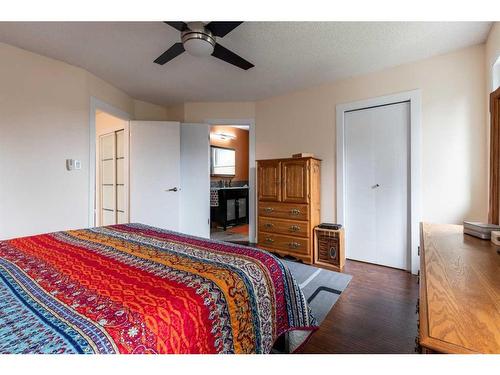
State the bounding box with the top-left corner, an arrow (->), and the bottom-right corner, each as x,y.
256,45 -> 487,223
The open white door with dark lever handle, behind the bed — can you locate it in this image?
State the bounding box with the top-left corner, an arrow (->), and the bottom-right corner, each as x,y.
129,121 -> 180,231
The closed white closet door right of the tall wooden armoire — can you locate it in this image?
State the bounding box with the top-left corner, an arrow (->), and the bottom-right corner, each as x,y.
344,102 -> 410,269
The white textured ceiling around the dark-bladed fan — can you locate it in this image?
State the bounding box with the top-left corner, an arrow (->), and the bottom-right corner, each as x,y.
0,22 -> 491,105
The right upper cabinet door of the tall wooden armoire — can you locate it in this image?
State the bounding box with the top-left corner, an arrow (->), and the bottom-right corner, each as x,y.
281,159 -> 309,203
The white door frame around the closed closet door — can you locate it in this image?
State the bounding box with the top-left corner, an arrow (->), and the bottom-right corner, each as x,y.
336,89 -> 422,274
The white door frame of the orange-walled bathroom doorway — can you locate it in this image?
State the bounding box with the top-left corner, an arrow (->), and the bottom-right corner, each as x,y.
203,119 -> 257,243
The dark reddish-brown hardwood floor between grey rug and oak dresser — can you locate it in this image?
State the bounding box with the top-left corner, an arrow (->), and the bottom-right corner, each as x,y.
302,260 -> 418,353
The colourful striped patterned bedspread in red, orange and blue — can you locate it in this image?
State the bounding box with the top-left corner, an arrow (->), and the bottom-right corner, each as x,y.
0,224 -> 317,353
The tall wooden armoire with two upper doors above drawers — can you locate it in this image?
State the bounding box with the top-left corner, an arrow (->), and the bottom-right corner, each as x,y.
257,157 -> 321,264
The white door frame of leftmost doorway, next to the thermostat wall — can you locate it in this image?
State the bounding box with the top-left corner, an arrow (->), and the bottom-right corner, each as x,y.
88,96 -> 132,227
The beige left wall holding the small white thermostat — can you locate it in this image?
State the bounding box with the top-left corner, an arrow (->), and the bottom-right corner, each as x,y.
0,43 -> 168,239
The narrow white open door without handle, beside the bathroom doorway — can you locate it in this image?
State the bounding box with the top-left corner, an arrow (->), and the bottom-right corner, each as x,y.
180,124 -> 210,238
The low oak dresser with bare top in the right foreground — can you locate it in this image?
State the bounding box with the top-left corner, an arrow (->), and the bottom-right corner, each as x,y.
418,224 -> 500,353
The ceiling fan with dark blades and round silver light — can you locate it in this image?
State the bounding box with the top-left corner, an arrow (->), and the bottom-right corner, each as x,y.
154,21 -> 255,70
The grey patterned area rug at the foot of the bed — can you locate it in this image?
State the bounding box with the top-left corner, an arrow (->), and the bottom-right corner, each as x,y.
273,259 -> 352,354
